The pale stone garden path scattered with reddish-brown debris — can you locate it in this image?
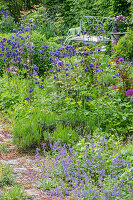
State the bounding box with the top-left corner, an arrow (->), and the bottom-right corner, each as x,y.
0,122 -> 52,200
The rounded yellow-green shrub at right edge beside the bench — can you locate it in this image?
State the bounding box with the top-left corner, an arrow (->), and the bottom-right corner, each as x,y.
113,30 -> 133,61
